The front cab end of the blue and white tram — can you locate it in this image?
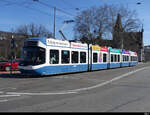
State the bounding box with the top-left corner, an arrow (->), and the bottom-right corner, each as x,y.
18,38 -> 46,75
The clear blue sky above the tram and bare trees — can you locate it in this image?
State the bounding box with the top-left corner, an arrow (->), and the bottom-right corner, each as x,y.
0,0 -> 150,45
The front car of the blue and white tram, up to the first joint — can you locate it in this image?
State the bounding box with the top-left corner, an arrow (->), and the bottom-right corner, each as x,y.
19,38 -> 88,75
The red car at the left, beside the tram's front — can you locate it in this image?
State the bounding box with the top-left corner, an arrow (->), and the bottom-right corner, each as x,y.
0,59 -> 20,71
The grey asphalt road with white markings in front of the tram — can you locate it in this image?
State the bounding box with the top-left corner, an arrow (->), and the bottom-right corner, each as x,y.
0,63 -> 150,112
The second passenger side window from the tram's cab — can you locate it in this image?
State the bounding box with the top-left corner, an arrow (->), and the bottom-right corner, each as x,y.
61,50 -> 70,64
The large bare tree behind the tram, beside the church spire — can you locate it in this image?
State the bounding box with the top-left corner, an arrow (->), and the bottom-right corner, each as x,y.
74,5 -> 140,43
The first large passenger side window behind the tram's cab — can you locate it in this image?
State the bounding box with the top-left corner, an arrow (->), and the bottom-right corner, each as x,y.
50,50 -> 59,64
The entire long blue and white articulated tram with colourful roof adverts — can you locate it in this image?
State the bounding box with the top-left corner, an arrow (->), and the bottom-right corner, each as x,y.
18,37 -> 138,75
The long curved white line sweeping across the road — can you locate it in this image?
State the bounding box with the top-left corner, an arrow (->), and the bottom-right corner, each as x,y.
6,67 -> 150,96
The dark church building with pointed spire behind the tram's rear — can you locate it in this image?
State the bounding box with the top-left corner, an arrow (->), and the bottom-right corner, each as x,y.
112,14 -> 145,62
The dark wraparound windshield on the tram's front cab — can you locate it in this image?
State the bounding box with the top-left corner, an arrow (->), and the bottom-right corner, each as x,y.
20,47 -> 45,66
